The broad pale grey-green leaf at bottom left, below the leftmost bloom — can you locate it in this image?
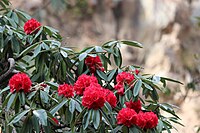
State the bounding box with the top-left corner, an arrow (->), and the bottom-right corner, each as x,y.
33,109 -> 47,126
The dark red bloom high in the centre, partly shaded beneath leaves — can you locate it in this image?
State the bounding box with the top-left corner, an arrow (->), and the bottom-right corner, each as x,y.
85,56 -> 104,73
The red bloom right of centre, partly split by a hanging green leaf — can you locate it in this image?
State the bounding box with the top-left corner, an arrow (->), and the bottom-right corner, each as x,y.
114,72 -> 135,95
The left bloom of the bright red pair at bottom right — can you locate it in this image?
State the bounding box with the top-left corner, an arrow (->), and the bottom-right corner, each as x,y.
117,108 -> 137,127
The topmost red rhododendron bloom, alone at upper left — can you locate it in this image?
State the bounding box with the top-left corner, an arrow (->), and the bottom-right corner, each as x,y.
24,18 -> 41,35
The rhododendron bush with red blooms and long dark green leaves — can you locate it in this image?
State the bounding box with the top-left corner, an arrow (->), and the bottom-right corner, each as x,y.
0,0 -> 181,133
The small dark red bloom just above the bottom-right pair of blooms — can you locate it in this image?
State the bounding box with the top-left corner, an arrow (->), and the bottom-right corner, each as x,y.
125,100 -> 142,113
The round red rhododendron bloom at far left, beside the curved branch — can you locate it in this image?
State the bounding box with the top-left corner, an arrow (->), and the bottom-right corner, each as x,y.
9,73 -> 32,93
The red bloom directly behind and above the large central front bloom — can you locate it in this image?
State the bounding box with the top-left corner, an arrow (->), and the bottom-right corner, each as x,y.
74,74 -> 98,95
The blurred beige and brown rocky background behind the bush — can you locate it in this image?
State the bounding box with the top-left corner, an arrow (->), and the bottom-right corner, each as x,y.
11,0 -> 200,133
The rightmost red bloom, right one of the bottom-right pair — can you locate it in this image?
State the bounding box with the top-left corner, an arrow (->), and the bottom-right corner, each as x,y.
136,112 -> 158,129
